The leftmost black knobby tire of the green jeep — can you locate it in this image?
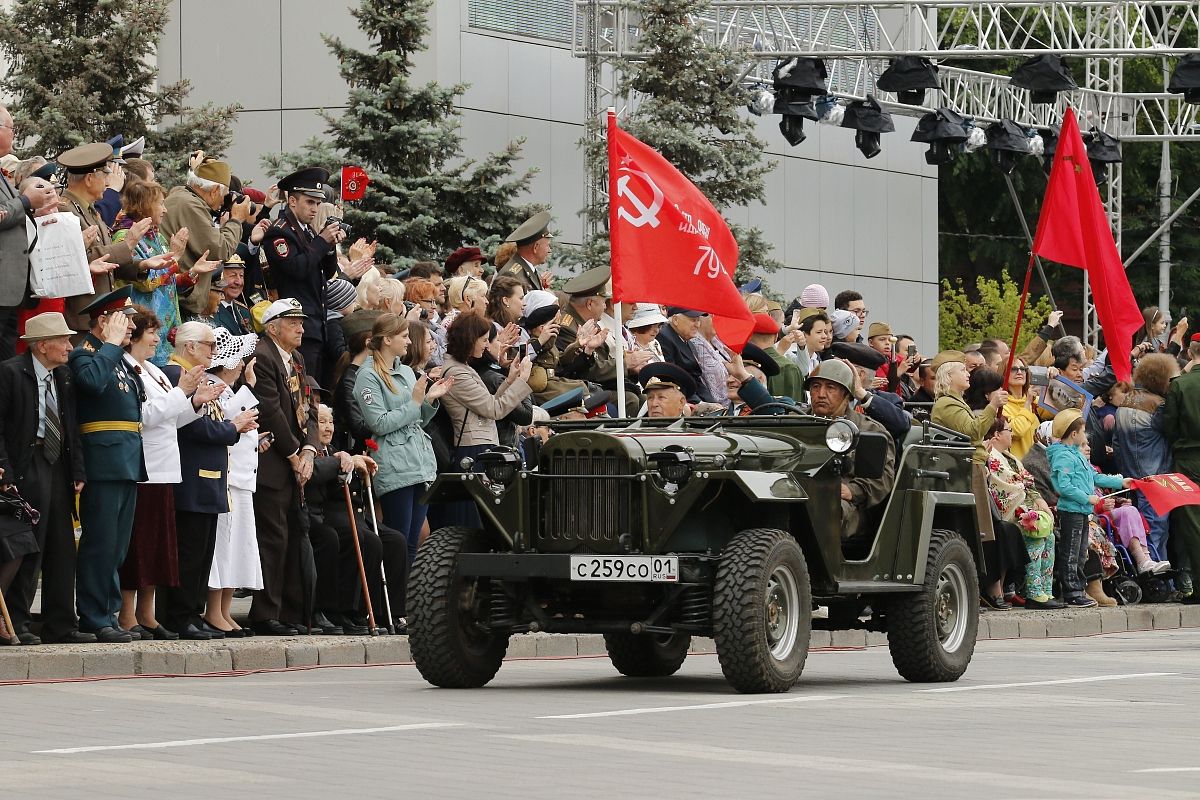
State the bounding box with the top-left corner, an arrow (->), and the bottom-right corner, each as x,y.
408,528 -> 509,688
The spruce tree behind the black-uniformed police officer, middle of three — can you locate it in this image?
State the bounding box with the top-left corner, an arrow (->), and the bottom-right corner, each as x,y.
270,0 -> 534,266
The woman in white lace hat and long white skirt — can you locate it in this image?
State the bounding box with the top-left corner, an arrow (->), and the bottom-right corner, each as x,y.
204,327 -> 271,638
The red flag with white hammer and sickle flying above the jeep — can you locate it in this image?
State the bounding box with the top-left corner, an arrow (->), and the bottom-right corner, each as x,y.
608,112 -> 754,351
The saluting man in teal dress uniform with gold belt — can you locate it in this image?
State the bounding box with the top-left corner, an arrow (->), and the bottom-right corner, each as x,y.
67,287 -> 146,642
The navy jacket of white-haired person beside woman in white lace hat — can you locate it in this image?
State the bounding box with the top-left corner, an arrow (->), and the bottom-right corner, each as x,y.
162,363 -> 241,513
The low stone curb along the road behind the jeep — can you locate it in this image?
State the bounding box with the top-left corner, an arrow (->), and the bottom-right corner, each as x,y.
0,603 -> 1200,684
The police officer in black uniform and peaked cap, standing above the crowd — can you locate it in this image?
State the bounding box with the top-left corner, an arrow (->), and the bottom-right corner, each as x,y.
264,167 -> 346,383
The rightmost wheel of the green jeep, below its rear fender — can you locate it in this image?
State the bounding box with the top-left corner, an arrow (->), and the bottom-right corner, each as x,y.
887,530 -> 979,684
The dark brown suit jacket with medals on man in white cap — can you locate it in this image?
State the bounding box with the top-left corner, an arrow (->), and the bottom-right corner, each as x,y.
252,336 -> 319,489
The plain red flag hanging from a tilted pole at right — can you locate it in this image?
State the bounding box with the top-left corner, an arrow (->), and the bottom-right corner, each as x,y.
1033,108 -> 1144,380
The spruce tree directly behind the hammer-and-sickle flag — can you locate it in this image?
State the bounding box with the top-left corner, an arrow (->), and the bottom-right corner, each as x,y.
583,0 -> 782,282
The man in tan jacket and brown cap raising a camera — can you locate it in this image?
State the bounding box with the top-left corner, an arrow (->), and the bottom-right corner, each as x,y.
159,151 -> 253,319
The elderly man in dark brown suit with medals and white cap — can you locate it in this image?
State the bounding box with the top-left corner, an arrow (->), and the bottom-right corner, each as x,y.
250,297 -> 320,636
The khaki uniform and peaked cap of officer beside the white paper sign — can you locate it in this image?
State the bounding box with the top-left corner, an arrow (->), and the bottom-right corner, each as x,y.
58,143 -> 142,331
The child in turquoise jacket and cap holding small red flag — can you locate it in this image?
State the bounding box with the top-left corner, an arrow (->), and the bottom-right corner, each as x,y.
1046,409 -> 1133,608
